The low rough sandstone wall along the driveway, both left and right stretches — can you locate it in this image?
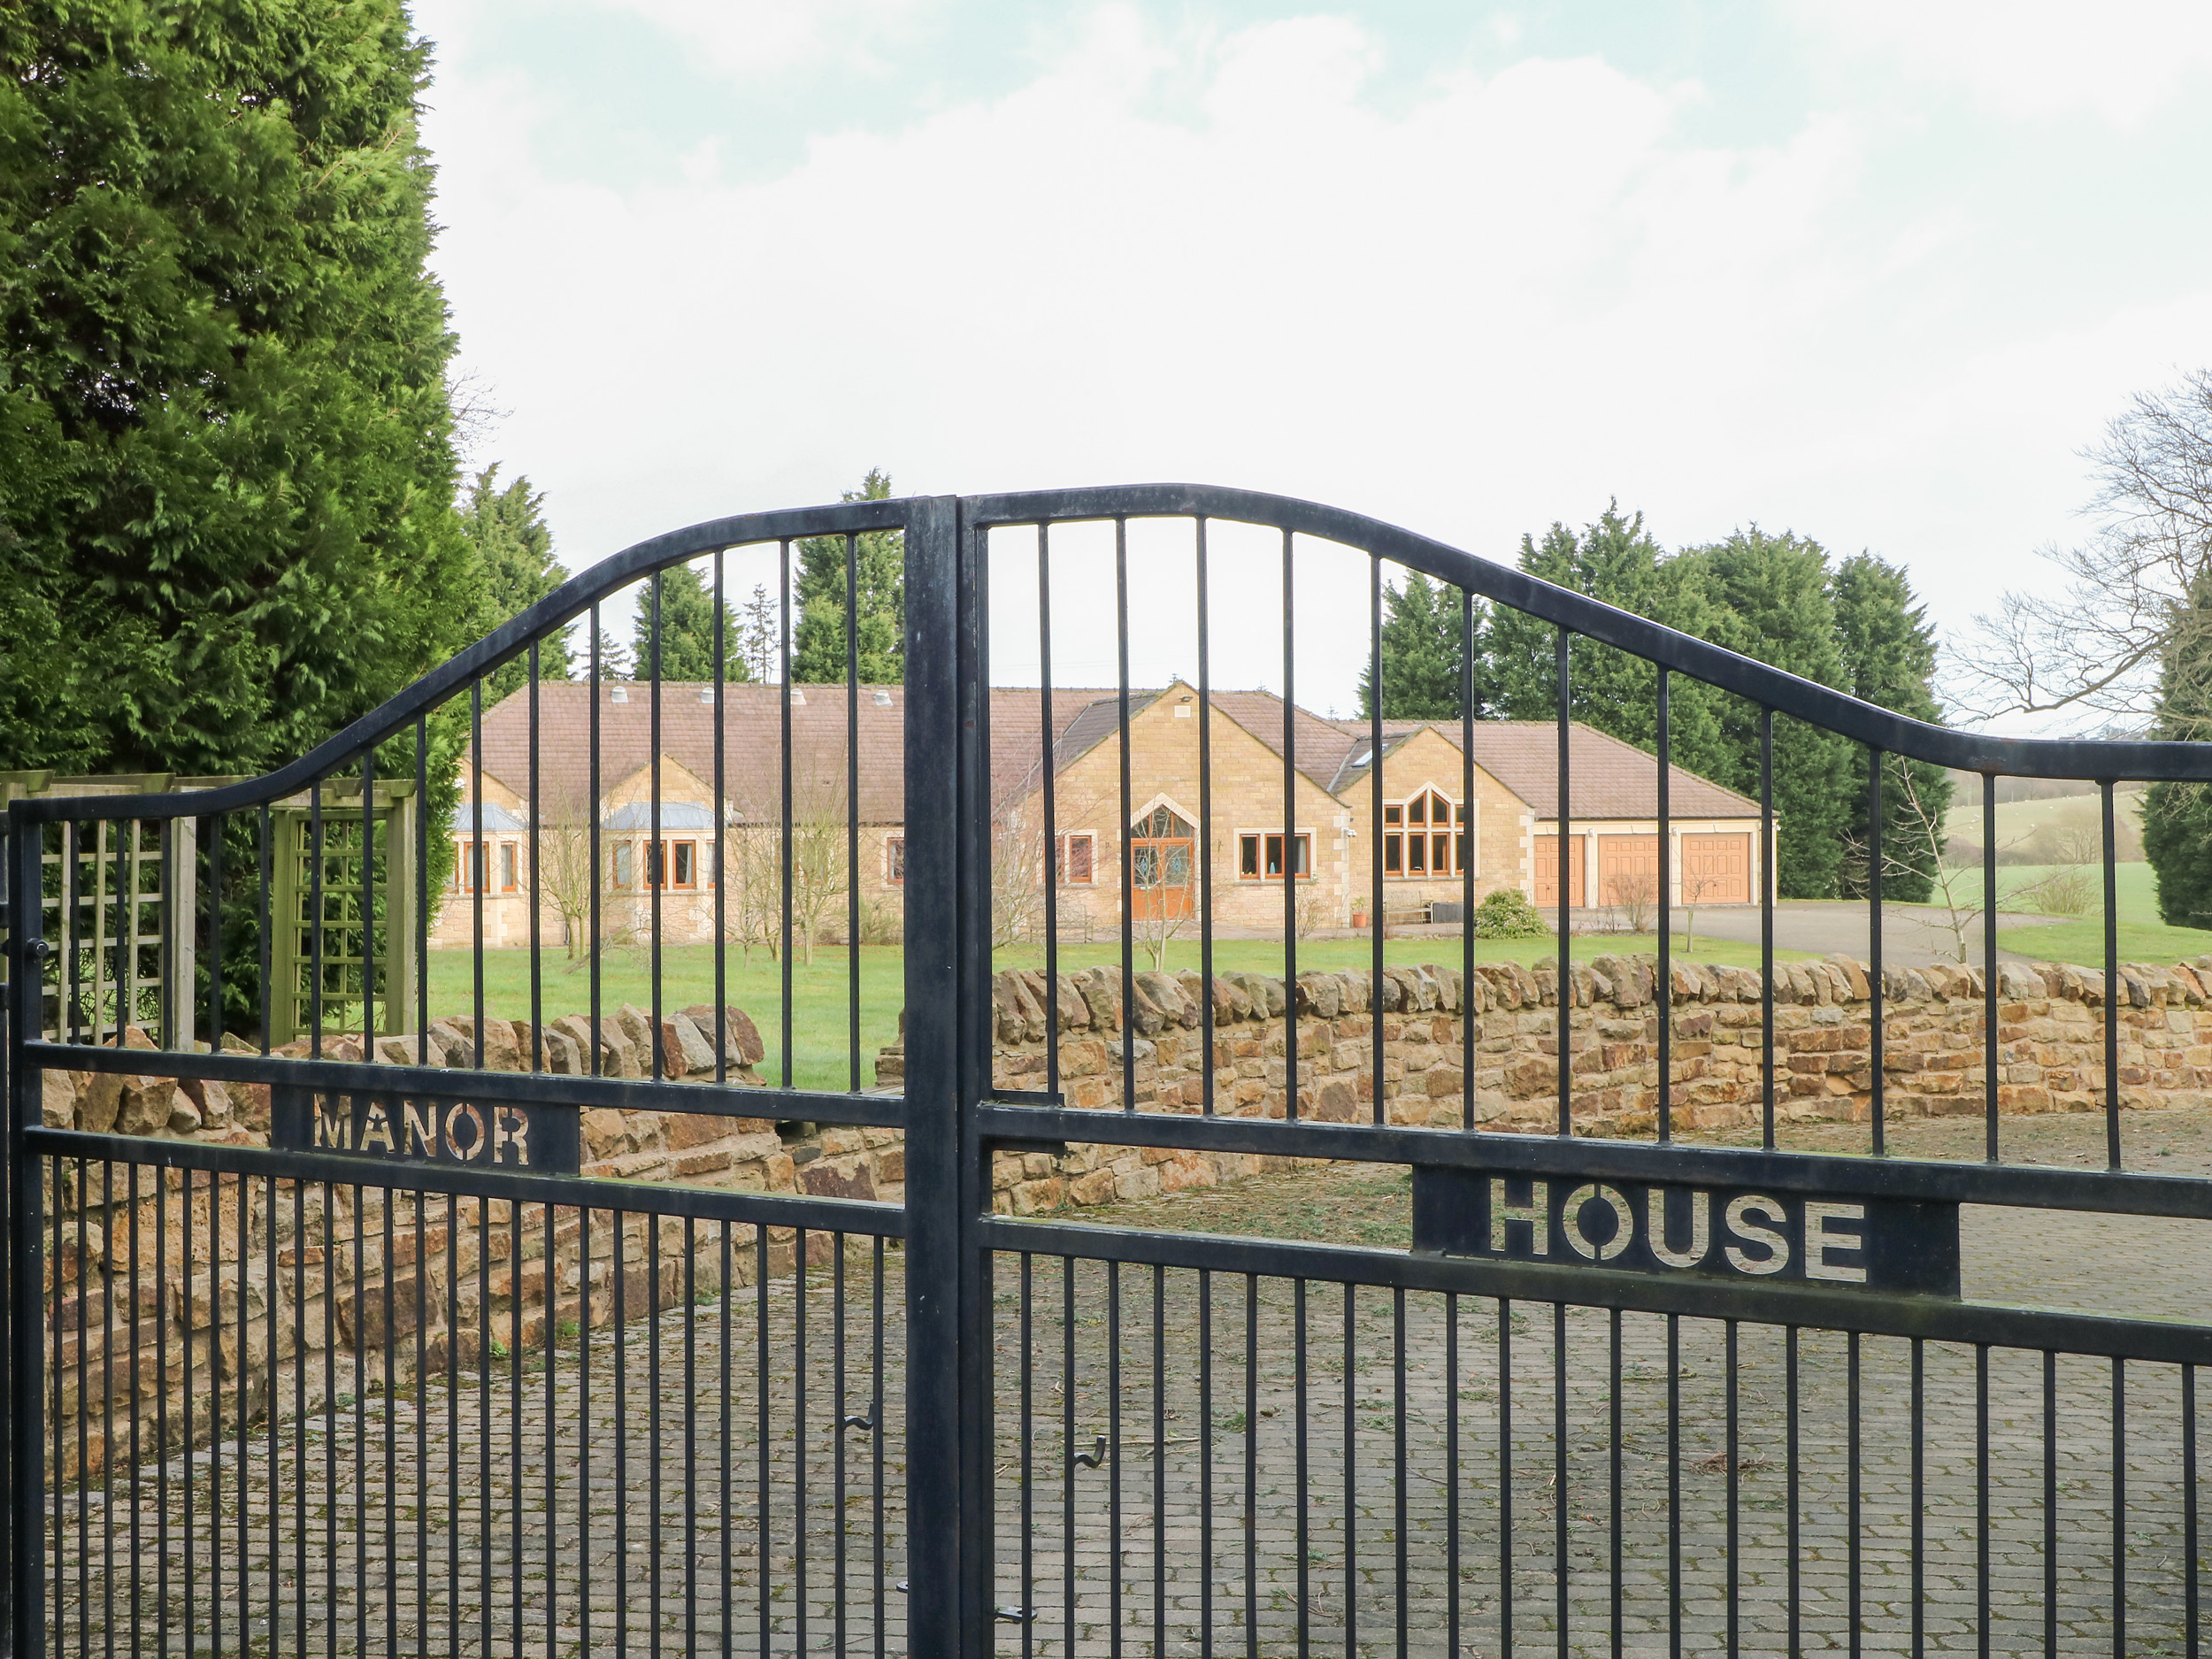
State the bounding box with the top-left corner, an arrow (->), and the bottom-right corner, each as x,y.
44,958 -> 2212,1473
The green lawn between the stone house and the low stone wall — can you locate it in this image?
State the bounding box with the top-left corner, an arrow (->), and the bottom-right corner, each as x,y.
429,933 -> 1805,1088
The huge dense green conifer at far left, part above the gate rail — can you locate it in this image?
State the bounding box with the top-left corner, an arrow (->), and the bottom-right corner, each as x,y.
0,0 -> 476,774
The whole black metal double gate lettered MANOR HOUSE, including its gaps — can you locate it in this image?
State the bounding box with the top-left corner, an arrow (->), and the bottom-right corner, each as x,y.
4,487 -> 2212,1659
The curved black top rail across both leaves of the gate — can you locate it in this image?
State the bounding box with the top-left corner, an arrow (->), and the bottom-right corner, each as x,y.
18,485 -> 2212,823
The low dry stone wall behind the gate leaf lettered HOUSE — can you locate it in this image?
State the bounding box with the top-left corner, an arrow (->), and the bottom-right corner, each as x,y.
879,956 -> 2212,1215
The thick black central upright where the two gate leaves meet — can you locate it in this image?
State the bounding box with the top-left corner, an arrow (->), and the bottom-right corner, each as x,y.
905,495 -> 995,1659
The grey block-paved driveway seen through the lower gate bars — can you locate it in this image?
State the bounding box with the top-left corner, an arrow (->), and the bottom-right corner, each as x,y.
47,1186 -> 2206,1655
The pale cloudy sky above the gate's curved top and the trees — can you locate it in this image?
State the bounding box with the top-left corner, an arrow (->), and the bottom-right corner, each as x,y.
416,0 -> 2212,717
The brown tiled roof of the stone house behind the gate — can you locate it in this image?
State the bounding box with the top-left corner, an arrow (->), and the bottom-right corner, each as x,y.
485,681 -> 1759,823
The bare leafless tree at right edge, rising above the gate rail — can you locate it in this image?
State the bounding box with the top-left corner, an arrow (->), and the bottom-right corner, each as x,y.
1947,370 -> 2212,737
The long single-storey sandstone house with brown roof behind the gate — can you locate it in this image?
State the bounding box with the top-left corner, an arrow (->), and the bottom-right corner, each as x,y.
432,681 -> 1761,949
